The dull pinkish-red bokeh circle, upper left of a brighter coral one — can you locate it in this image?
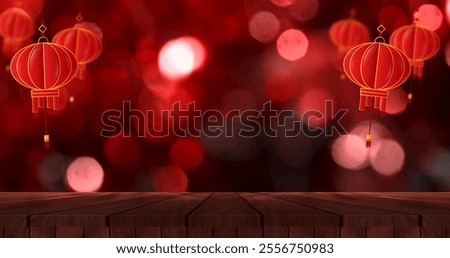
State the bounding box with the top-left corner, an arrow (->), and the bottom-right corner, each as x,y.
248,12 -> 280,43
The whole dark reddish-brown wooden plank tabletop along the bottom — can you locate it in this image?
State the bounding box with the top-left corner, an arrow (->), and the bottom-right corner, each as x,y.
0,193 -> 450,238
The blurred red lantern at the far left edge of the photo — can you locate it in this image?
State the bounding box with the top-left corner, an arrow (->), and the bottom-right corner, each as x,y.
0,7 -> 35,56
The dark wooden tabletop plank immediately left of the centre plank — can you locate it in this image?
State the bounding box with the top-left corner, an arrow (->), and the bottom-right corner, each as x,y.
109,193 -> 211,237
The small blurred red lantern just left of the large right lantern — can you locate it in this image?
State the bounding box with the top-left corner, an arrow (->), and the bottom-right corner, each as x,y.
329,19 -> 370,55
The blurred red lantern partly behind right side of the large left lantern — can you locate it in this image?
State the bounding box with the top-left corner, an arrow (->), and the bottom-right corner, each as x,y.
53,24 -> 102,79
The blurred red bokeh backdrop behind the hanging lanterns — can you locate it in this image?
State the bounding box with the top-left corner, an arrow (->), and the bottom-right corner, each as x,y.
0,0 -> 450,191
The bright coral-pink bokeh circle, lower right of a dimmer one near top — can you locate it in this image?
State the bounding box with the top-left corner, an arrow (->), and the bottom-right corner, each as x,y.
277,29 -> 309,61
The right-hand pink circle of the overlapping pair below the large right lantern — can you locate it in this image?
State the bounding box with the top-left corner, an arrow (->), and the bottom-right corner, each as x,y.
370,140 -> 405,176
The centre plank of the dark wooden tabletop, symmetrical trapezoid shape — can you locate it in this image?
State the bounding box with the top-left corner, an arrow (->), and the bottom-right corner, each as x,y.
189,193 -> 261,228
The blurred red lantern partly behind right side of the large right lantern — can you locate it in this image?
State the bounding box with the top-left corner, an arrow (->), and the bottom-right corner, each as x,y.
390,23 -> 440,80
